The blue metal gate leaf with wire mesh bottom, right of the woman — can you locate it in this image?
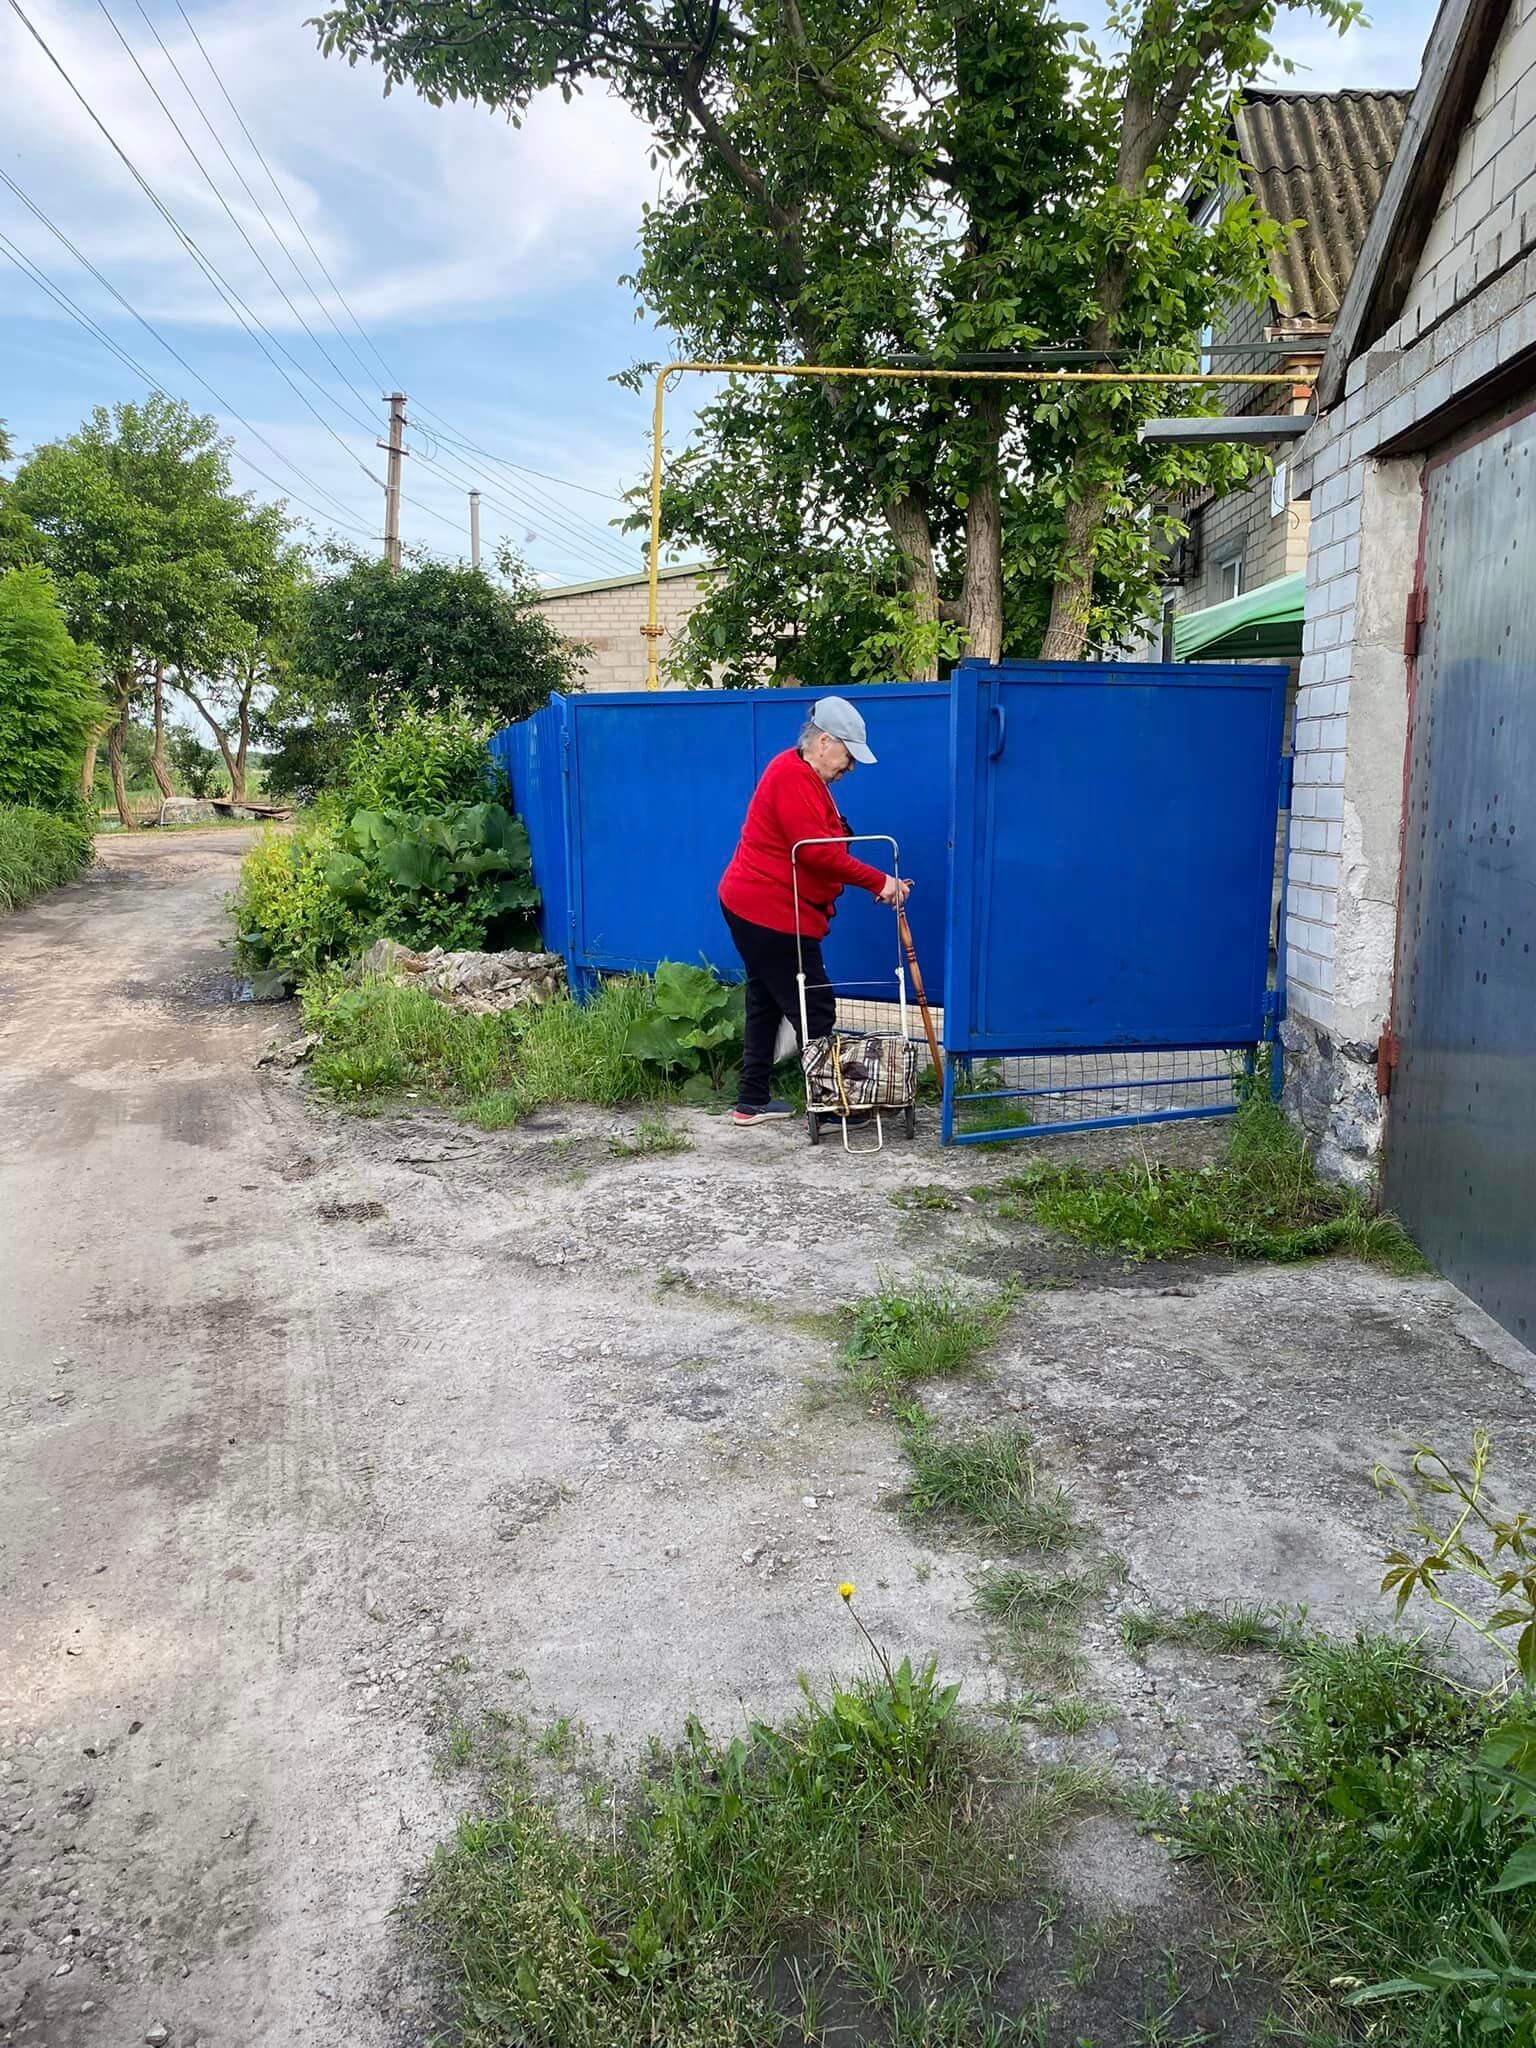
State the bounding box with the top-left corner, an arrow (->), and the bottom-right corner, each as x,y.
942,662 -> 1286,1143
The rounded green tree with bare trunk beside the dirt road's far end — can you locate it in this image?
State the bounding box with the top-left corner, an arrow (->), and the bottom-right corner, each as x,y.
8,395 -> 283,829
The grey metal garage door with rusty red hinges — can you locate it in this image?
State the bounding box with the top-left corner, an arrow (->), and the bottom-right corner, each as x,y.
1386,416 -> 1536,1343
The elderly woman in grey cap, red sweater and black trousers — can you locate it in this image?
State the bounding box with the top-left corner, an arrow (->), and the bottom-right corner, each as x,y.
721,696 -> 911,1124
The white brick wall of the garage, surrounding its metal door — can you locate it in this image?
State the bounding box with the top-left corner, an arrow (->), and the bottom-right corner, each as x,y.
1286,0 -> 1536,1178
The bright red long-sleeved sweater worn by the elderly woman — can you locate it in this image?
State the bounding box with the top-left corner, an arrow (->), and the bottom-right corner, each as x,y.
721,748 -> 885,938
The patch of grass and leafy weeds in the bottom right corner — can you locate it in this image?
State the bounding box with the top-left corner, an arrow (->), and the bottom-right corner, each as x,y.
1176,1636 -> 1536,2048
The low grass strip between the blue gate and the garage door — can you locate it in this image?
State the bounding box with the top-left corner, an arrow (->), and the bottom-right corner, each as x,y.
999,1096 -> 1425,1274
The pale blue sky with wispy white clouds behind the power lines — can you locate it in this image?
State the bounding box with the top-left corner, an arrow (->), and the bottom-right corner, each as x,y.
0,0 -> 1434,584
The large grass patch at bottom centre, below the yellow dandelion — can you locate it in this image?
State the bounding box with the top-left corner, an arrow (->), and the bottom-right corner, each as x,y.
420,1663 -> 1098,2048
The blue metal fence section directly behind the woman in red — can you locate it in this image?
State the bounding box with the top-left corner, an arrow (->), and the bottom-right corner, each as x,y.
494,684 -> 950,999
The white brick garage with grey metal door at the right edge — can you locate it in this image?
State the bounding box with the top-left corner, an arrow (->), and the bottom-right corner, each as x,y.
1286,0 -> 1536,1341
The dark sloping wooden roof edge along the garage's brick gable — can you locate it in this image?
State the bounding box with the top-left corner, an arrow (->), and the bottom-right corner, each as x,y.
1317,0 -> 1509,412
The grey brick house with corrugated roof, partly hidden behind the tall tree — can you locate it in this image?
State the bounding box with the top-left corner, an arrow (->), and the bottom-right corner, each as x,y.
1167,92 -> 1411,657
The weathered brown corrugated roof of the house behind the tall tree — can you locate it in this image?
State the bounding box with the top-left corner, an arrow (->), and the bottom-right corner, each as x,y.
1235,92 -> 1413,324
